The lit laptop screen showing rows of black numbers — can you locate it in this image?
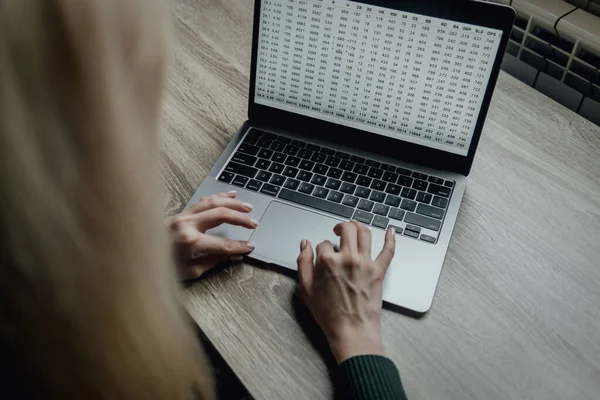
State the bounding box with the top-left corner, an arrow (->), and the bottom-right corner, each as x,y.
254,0 -> 502,156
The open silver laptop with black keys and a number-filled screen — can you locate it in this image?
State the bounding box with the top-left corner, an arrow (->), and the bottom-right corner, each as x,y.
189,0 -> 515,315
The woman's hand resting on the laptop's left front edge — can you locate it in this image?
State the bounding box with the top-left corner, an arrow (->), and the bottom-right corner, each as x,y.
169,191 -> 258,280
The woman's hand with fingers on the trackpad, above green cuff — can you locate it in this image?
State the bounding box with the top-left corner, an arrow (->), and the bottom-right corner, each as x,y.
298,221 -> 396,363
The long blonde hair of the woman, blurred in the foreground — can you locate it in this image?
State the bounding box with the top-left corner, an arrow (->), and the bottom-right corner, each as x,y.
0,0 -> 213,399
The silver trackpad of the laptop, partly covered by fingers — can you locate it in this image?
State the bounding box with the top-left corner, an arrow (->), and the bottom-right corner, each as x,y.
250,201 -> 385,269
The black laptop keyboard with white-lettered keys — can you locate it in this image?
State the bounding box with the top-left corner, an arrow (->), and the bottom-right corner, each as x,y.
218,129 -> 454,243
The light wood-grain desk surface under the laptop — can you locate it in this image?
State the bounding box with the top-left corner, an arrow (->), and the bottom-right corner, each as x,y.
163,0 -> 600,400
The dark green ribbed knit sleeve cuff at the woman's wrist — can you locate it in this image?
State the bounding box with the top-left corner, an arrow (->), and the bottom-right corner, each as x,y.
339,355 -> 406,400
